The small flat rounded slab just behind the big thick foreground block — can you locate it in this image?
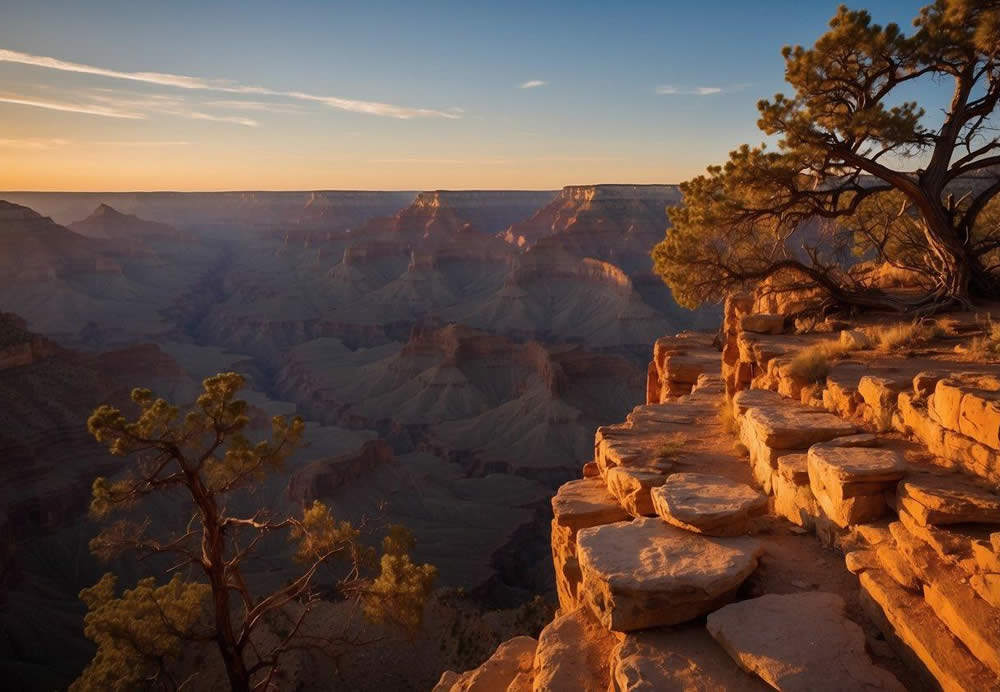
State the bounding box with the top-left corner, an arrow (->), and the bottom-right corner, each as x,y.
650,473 -> 767,536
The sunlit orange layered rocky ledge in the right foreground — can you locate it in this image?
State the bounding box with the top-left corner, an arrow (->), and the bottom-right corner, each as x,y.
435,297 -> 1000,692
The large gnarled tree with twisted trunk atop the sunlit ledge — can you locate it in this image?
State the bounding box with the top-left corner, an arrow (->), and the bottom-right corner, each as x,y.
653,0 -> 1000,310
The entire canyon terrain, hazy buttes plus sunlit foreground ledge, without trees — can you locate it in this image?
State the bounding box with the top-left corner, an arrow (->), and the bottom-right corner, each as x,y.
7,185 -> 1000,692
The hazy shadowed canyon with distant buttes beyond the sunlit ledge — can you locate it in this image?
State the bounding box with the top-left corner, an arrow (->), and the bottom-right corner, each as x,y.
0,185 -> 719,689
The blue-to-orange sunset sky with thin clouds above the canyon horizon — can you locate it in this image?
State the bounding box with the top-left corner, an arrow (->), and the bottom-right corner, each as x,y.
0,0 -> 923,191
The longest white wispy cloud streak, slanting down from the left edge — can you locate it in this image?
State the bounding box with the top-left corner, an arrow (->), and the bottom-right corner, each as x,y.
0,49 -> 461,120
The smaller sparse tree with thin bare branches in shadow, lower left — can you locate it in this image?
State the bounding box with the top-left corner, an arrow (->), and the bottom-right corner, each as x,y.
74,373 -> 436,692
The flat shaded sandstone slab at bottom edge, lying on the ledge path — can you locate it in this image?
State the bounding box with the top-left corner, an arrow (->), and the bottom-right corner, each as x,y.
707,591 -> 904,692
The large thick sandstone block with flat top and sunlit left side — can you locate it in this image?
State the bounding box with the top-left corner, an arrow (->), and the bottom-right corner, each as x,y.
577,518 -> 763,632
